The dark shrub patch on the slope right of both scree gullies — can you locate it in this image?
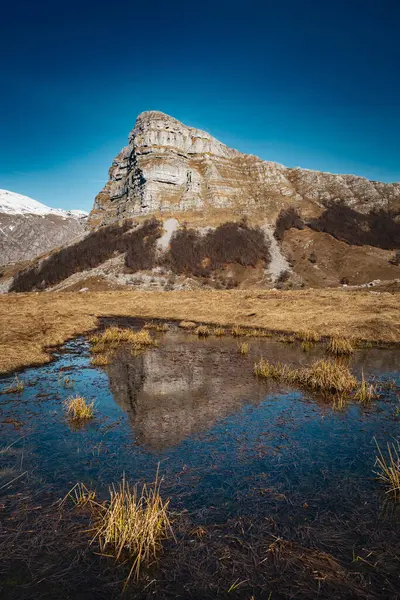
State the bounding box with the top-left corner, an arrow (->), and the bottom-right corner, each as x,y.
275,202 -> 400,250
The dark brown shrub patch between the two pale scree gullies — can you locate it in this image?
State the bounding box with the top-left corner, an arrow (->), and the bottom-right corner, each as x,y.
165,222 -> 270,277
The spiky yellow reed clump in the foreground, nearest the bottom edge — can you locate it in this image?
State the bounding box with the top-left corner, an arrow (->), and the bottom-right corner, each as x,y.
92,473 -> 173,587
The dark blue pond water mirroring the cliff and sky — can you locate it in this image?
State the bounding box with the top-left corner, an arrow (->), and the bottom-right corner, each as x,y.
0,320 -> 400,599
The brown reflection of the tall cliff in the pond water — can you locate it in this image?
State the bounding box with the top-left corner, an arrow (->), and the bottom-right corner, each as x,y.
107,341 -> 266,450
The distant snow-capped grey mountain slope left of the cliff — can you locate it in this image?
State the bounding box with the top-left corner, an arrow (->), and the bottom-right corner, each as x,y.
0,190 -> 87,265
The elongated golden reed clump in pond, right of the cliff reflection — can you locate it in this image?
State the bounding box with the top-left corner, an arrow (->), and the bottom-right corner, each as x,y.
254,359 -> 358,394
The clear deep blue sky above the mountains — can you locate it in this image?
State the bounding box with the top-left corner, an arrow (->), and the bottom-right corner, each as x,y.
0,0 -> 400,210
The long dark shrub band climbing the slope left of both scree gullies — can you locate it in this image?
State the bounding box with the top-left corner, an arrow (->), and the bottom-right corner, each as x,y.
11,219 -> 161,292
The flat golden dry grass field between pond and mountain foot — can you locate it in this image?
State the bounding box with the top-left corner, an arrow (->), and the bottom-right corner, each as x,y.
0,290 -> 400,373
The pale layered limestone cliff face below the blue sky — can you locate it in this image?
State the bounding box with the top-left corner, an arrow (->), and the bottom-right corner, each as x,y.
89,111 -> 400,227
